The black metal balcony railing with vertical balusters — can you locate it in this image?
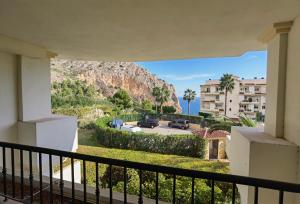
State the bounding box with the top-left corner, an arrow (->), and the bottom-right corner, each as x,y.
0,142 -> 300,204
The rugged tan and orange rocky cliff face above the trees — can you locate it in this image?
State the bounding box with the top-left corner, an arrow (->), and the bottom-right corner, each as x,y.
51,60 -> 181,111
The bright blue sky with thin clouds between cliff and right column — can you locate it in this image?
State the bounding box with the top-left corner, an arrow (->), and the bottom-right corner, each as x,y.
136,51 -> 267,96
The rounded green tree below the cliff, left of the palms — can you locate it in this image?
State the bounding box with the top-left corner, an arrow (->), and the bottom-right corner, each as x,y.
109,89 -> 132,110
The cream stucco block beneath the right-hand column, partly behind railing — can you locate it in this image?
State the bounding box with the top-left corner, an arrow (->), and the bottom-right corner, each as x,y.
227,127 -> 298,204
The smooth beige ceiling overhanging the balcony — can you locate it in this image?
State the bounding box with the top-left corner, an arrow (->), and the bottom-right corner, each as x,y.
0,0 -> 300,61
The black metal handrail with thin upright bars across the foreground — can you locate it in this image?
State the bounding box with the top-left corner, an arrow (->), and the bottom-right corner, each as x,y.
0,142 -> 300,203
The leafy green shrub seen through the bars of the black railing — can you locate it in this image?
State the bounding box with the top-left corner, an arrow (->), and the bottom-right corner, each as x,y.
101,167 -> 227,203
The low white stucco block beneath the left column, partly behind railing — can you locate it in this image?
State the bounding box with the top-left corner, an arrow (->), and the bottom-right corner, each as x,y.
18,115 -> 78,175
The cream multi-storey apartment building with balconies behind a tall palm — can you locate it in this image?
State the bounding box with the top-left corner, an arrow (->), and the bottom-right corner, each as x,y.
200,76 -> 266,119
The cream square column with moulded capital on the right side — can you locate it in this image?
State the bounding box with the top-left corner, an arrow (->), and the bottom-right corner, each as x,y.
265,22 -> 292,138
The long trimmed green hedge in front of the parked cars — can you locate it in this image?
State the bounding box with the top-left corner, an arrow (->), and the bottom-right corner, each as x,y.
96,117 -> 206,158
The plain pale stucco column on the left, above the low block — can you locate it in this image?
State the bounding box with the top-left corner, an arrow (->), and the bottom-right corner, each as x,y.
19,56 -> 51,121
